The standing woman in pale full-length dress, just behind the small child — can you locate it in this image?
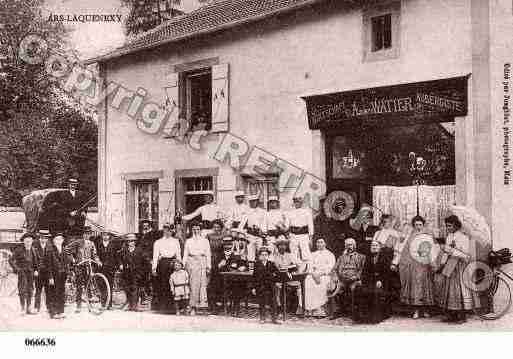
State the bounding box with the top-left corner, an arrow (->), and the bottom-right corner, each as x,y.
183,223 -> 211,315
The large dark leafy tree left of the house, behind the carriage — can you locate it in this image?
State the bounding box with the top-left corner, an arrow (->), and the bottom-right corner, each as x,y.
0,0 -> 97,206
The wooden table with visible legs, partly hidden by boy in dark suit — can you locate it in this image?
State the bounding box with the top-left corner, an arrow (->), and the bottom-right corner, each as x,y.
219,271 -> 308,320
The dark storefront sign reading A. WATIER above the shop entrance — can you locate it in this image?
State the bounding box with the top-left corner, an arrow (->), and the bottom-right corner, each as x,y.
303,76 -> 467,129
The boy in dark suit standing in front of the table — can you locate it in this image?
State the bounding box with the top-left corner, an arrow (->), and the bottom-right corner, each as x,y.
253,246 -> 280,324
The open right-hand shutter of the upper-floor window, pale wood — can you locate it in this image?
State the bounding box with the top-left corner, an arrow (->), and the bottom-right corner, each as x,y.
212,64 -> 229,132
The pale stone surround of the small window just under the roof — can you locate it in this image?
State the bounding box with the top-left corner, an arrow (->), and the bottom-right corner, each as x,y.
362,0 -> 401,62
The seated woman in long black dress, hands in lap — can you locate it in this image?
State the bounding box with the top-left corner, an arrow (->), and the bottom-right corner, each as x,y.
353,240 -> 393,324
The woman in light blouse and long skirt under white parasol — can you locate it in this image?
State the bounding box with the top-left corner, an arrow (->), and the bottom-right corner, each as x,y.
440,215 -> 480,323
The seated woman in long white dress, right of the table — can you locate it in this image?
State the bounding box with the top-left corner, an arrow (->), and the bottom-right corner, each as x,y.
305,238 -> 335,317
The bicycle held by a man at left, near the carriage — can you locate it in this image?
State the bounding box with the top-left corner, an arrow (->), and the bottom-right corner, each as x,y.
72,259 -> 111,315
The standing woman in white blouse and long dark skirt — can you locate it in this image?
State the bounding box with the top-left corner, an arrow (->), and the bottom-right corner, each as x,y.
151,223 -> 182,312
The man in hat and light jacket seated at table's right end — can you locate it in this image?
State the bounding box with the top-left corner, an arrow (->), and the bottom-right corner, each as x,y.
274,236 -> 303,314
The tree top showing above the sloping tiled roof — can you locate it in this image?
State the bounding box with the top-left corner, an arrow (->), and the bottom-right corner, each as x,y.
121,0 -> 183,36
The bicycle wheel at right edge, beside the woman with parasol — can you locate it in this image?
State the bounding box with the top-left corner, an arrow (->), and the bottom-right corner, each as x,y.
474,276 -> 511,320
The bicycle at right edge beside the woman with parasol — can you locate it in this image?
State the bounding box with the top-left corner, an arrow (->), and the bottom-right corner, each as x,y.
474,250 -> 513,320
